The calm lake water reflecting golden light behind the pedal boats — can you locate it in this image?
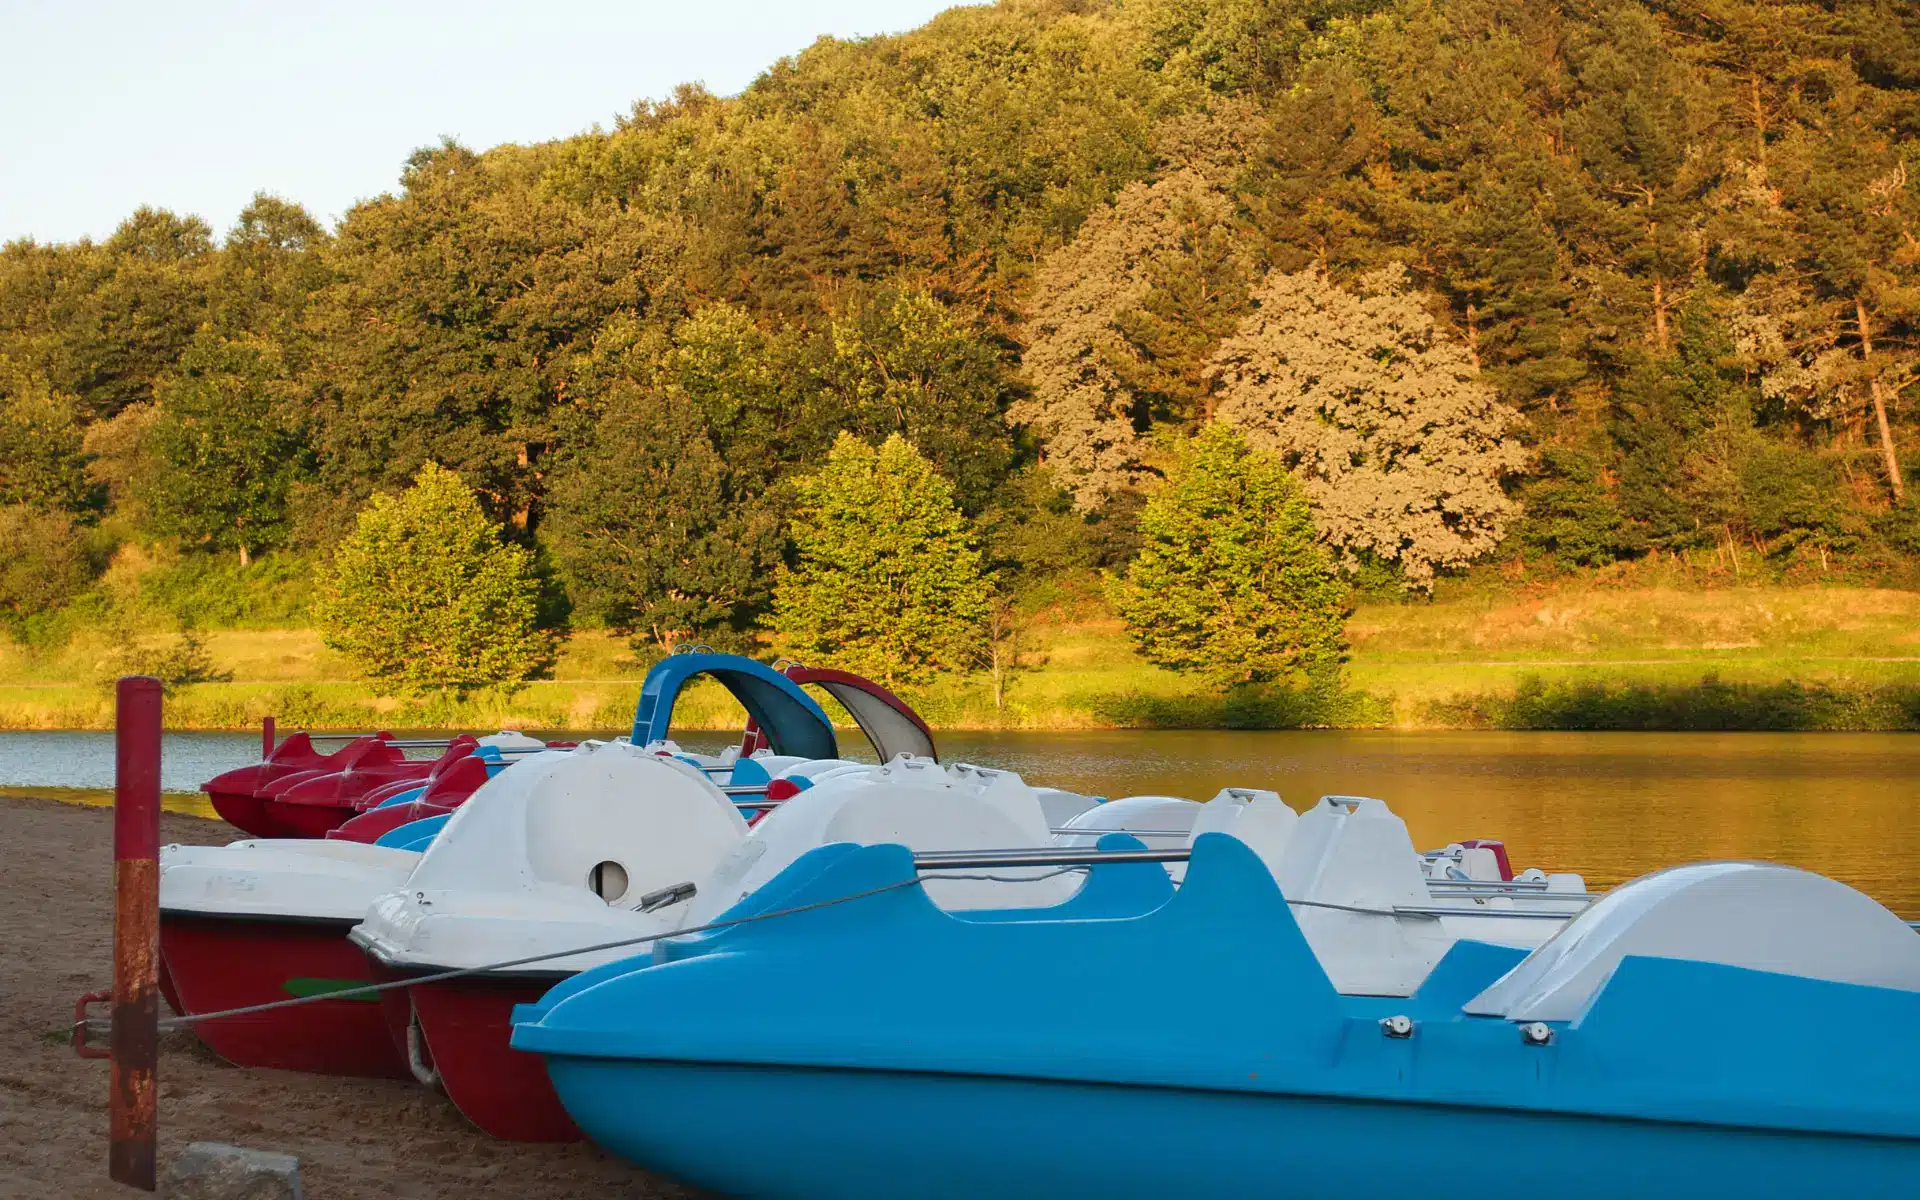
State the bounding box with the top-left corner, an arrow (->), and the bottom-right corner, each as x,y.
0,730 -> 1920,918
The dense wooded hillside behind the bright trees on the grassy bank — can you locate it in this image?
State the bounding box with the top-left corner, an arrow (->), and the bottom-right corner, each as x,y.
0,0 -> 1920,710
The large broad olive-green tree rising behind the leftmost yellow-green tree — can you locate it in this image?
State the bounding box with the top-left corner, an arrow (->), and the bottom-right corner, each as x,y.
307,142 -> 645,526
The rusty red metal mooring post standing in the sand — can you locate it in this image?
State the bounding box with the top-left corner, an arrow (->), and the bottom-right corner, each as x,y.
108,676 -> 159,1192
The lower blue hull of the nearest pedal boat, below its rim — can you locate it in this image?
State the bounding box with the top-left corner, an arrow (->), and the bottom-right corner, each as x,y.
549,1059 -> 1920,1200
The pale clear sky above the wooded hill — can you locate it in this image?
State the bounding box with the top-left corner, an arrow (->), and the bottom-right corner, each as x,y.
0,0 -> 960,242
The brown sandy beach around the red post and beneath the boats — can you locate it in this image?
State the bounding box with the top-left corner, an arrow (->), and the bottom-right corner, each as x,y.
0,797 -> 697,1200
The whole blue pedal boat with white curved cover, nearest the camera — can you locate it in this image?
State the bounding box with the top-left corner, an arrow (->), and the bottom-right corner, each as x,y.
513,833 -> 1920,1200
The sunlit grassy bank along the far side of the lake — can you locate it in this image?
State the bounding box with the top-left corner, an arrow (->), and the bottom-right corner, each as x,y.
0,588 -> 1920,730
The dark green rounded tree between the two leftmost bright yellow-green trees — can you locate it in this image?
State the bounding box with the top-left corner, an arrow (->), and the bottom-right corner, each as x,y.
541,380 -> 780,649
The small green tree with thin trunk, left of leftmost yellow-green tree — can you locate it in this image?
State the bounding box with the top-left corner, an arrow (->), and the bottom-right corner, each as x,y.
144,330 -> 311,566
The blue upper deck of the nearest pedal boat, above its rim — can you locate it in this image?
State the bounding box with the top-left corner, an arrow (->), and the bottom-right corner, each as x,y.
515,835 -> 1920,1162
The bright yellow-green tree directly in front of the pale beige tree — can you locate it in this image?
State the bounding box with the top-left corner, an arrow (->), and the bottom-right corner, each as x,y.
1108,424 -> 1348,685
